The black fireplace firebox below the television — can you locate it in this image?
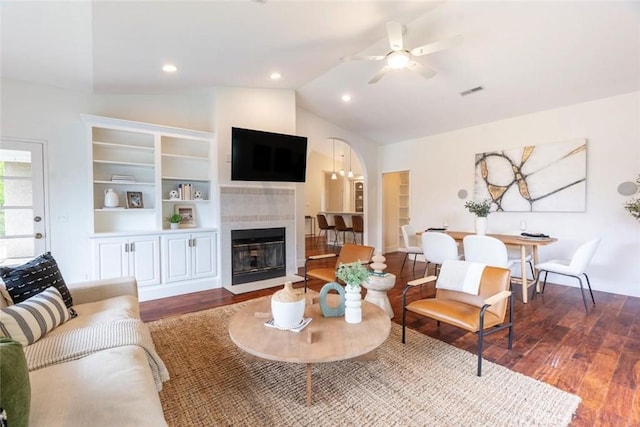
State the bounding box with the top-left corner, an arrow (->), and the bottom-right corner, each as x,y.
231,227 -> 287,285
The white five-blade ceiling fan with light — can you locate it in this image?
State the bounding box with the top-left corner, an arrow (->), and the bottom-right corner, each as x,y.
345,22 -> 462,84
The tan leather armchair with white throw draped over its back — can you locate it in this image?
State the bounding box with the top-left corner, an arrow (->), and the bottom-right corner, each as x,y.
402,261 -> 514,376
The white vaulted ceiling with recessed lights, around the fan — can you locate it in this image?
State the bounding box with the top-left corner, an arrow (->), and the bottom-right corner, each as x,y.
0,0 -> 640,144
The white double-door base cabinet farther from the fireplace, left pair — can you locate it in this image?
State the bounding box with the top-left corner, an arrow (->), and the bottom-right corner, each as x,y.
93,235 -> 160,286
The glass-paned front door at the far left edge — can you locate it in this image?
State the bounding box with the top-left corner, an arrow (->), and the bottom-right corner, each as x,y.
0,139 -> 48,265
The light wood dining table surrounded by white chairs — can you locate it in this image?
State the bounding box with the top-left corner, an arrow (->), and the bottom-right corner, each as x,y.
417,230 -> 558,304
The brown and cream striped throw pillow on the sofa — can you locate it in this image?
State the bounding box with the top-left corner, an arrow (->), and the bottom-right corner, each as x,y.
0,286 -> 71,345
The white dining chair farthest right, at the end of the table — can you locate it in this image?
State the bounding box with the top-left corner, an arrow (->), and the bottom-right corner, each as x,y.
532,238 -> 600,313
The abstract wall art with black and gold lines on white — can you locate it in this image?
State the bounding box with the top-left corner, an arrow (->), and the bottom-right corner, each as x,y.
474,139 -> 587,212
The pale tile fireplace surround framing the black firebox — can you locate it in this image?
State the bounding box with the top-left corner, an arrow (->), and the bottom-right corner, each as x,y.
220,186 -> 302,294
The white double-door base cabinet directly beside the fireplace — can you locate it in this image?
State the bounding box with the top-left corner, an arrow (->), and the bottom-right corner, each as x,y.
162,232 -> 217,283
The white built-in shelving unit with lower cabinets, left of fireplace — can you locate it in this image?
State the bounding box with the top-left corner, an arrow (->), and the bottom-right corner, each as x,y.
82,115 -> 219,299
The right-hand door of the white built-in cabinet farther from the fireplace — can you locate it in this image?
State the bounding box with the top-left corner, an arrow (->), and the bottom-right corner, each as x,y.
129,236 -> 160,286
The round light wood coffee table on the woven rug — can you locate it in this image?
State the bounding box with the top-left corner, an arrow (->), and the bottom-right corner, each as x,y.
229,293 -> 391,405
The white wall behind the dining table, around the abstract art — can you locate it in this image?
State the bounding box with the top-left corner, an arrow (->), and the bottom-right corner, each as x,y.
380,92 -> 640,303
